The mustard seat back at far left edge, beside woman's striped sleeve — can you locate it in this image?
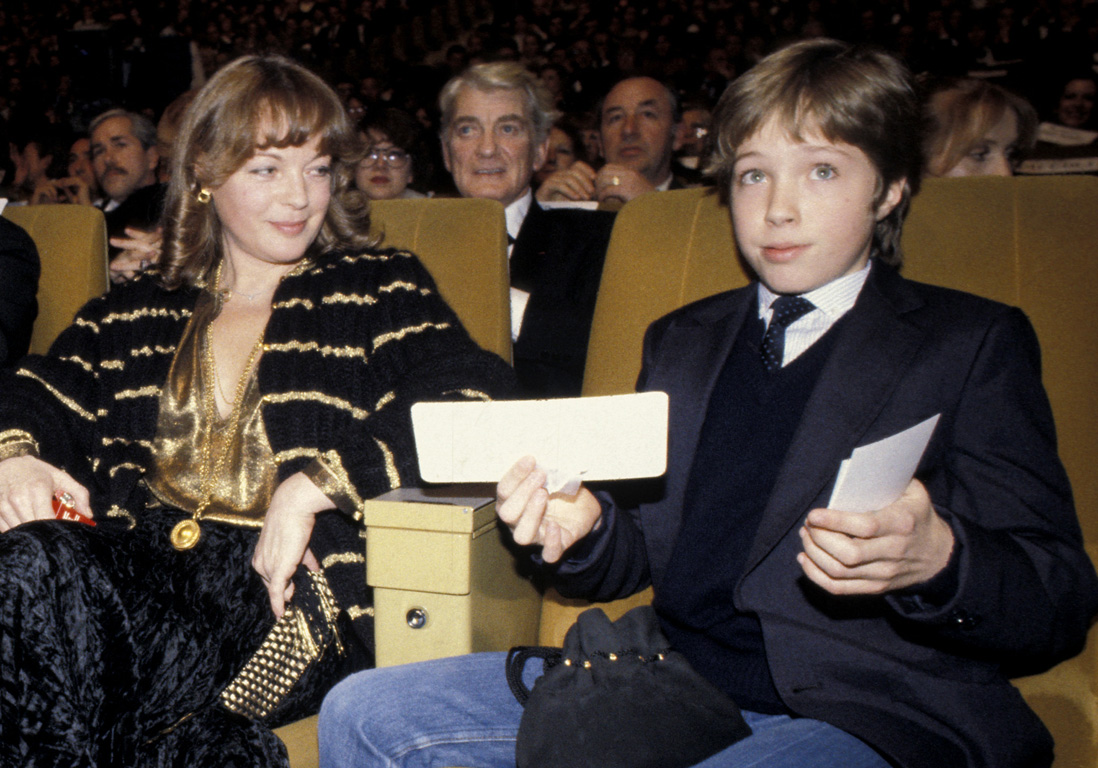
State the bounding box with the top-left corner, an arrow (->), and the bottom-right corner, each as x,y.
3,204 -> 107,354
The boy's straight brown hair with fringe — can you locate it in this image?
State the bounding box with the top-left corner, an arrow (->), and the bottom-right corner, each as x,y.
708,40 -> 920,266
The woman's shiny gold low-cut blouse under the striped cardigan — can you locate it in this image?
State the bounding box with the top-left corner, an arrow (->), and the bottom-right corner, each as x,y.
146,290 -> 277,527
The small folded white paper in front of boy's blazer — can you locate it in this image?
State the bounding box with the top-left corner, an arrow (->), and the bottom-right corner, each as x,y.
828,413 -> 941,512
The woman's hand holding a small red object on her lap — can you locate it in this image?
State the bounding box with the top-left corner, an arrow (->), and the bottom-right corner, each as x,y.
0,456 -> 93,533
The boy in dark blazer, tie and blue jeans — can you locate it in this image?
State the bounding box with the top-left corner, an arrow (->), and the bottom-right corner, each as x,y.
321,41 -> 1098,768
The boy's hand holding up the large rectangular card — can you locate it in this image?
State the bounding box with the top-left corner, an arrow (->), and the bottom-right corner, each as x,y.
495,456 -> 603,563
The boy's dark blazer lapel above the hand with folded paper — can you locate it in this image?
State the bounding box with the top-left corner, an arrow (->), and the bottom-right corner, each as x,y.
748,265 -> 925,570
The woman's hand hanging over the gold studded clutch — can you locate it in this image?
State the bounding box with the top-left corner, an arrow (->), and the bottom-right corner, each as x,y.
251,472 -> 336,619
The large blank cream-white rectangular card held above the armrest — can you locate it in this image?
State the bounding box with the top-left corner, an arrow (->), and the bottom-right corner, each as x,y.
412,392 -> 668,485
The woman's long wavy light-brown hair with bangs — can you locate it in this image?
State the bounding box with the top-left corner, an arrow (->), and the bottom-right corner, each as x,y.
160,56 -> 377,289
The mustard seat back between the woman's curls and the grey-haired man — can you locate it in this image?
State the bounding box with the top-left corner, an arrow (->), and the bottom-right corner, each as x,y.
370,198 -> 511,363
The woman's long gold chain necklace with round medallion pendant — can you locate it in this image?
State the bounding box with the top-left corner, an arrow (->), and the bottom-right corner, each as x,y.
171,263 -> 264,550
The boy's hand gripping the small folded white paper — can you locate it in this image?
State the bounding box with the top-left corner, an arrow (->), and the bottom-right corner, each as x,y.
797,480 -> 953,594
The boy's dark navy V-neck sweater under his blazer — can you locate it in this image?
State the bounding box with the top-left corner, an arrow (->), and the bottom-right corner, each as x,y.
657,309 -> 841,714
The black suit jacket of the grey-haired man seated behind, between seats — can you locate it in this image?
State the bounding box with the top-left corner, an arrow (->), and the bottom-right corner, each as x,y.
511,200 -> 615,398
